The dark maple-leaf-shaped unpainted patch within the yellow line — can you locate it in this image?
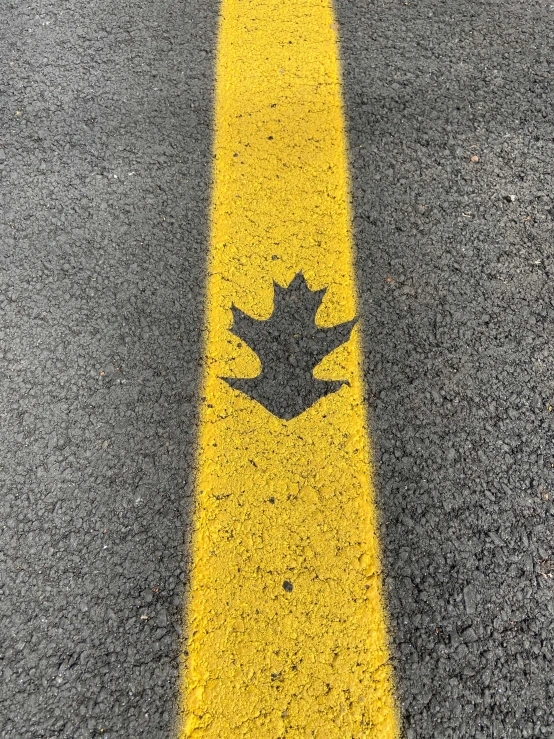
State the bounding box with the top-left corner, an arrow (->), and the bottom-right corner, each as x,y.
221,272 -> 357,421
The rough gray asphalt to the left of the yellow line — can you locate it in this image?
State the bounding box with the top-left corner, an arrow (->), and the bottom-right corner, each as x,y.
0,0 -> 216,739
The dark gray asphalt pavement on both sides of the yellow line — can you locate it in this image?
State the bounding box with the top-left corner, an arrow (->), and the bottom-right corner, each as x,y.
0,0 -> 554,739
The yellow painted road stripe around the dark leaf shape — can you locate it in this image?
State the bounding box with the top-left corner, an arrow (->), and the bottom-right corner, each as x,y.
179,0 -> 399,739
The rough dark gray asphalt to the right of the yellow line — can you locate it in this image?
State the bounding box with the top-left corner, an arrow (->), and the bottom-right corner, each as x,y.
338,0 -> 554,739
